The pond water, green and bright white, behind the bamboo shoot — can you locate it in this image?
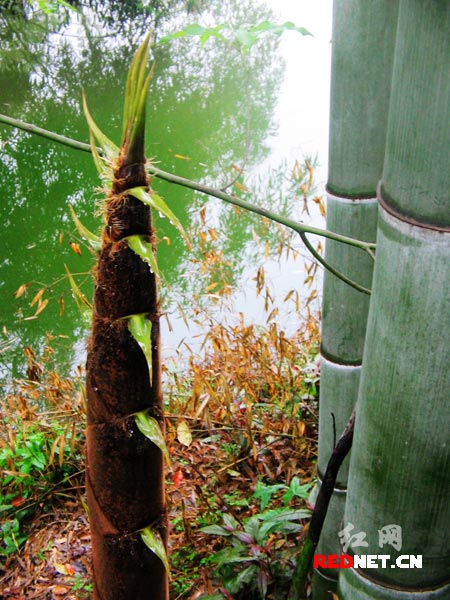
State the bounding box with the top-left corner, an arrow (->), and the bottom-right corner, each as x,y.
0,0 -> 331,379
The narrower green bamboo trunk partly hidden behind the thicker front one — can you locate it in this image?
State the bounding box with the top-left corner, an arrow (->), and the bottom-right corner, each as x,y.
313,0 -> 398,600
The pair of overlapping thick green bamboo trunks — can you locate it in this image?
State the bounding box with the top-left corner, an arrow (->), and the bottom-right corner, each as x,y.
313,0 -> 450,600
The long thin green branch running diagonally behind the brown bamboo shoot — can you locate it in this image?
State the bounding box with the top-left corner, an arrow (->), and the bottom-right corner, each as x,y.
0,114 -> 376,255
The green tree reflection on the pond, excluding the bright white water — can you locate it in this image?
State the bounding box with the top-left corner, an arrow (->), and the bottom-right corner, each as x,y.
0,0 -> 282,376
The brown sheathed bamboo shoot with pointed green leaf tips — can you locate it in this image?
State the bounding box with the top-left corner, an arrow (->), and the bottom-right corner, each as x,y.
84,36 -> 168,600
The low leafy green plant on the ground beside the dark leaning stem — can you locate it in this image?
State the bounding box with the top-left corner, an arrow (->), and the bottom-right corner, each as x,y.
201,478 -> 311,600
